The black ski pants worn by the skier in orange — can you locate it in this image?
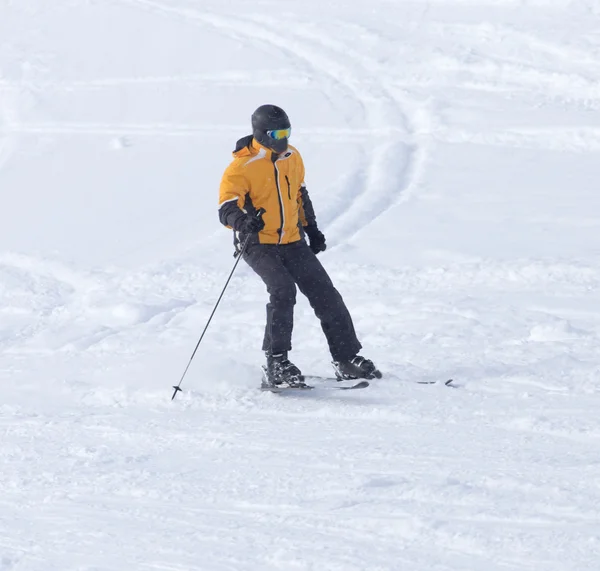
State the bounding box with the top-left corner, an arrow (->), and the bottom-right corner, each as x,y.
244,240 -> 361,361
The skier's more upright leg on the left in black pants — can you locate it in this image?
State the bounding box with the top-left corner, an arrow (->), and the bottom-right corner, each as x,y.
244,244 -> 296,355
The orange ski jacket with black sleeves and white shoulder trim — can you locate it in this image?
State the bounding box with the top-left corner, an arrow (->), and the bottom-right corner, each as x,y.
219,135 -> 316,249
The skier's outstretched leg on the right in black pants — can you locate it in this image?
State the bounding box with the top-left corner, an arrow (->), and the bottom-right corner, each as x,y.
281,240 -> 361,361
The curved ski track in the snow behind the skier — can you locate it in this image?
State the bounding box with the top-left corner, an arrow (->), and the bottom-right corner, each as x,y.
227,13 -> 424,242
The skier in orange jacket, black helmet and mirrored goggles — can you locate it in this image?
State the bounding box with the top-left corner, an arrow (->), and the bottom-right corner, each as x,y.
219,105 -> 381,388
